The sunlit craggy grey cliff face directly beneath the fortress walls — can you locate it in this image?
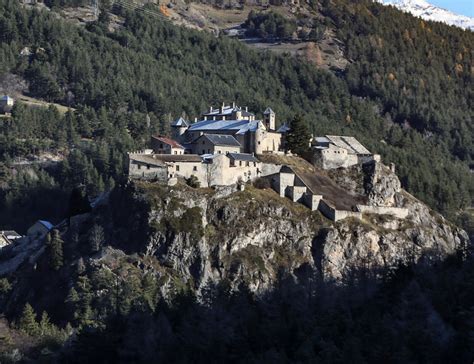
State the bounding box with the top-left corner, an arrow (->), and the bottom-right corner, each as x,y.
103,180 -> 467,292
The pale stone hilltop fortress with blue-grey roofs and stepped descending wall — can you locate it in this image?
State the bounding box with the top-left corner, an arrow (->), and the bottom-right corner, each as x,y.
128,103 -> 408,221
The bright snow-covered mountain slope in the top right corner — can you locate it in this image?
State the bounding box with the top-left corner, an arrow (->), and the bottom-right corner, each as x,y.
377,0 -> 474,31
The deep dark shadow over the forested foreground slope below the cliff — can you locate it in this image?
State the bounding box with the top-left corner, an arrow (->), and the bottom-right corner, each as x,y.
62,249 -> 474,363
